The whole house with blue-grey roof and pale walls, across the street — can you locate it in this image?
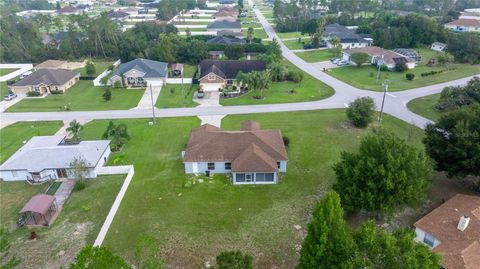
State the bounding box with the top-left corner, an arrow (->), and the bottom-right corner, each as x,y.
109,58 -> 168,87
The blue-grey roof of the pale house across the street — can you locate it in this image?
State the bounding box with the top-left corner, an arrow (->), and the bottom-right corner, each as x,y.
112,58 -> 168,78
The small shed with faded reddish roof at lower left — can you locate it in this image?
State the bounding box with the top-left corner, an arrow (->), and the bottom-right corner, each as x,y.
20,194 -> 58,226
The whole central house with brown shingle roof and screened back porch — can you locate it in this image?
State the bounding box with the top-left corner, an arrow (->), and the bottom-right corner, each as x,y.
182,121 -> 288,184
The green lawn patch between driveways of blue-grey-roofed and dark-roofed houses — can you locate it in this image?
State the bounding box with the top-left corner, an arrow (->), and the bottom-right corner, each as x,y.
155,84 -> 198,108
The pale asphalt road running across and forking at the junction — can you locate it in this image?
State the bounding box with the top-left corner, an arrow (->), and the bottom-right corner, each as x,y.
0,0 -> 480,128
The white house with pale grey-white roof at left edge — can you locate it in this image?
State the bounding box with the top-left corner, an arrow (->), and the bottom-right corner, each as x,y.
0,135 -> 110,183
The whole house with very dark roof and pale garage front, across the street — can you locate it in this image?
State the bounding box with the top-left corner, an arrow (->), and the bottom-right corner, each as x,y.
199,60 -> 267,92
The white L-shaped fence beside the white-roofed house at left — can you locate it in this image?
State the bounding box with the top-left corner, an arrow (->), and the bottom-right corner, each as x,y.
93,165 -> 135,246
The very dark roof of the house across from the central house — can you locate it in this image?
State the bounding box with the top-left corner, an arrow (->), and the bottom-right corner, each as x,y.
200,60 -> 267,79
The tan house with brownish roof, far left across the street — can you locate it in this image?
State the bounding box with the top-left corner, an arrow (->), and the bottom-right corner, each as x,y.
10,69 -> 80,95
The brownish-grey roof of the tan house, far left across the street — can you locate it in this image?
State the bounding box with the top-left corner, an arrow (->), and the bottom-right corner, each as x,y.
12,69 -> 80,86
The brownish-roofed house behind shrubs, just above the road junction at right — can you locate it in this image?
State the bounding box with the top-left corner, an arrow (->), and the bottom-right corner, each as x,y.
342,46 -> 416,70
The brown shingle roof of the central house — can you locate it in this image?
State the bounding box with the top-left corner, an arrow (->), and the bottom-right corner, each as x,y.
183,120 -> 288,172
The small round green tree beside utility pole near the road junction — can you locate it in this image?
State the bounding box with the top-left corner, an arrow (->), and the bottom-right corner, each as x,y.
346,97 -> 375,128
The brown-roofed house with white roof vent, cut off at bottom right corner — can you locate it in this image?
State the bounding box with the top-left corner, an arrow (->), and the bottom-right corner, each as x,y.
414,194 -> 480,269
